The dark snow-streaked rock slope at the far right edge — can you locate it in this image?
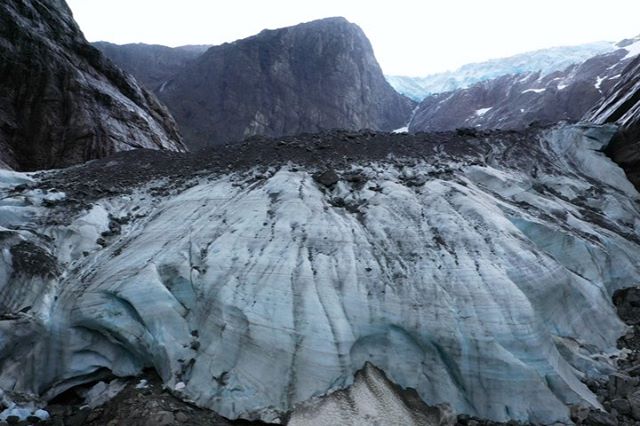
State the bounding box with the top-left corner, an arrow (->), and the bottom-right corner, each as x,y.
585,52 -> 640,188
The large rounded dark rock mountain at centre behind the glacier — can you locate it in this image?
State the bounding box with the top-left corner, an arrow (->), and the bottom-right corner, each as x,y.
152,18 -> 413,148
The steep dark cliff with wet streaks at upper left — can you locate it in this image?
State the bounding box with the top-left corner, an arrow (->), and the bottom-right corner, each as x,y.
0,0 -> 185,170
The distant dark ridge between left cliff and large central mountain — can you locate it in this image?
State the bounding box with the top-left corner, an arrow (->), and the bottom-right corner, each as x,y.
92,41 -> 211,91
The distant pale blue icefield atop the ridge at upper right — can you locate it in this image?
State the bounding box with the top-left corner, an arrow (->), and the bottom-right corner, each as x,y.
387,42 -> 622,101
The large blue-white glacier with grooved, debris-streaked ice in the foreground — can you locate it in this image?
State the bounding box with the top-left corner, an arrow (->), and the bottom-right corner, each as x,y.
0,125 -> 640,424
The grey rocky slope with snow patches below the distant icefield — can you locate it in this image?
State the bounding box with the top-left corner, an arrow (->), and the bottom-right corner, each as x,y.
409,42 -> 640,131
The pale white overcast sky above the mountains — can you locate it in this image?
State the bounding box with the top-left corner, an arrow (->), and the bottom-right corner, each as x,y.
67,0 -> 640,76
